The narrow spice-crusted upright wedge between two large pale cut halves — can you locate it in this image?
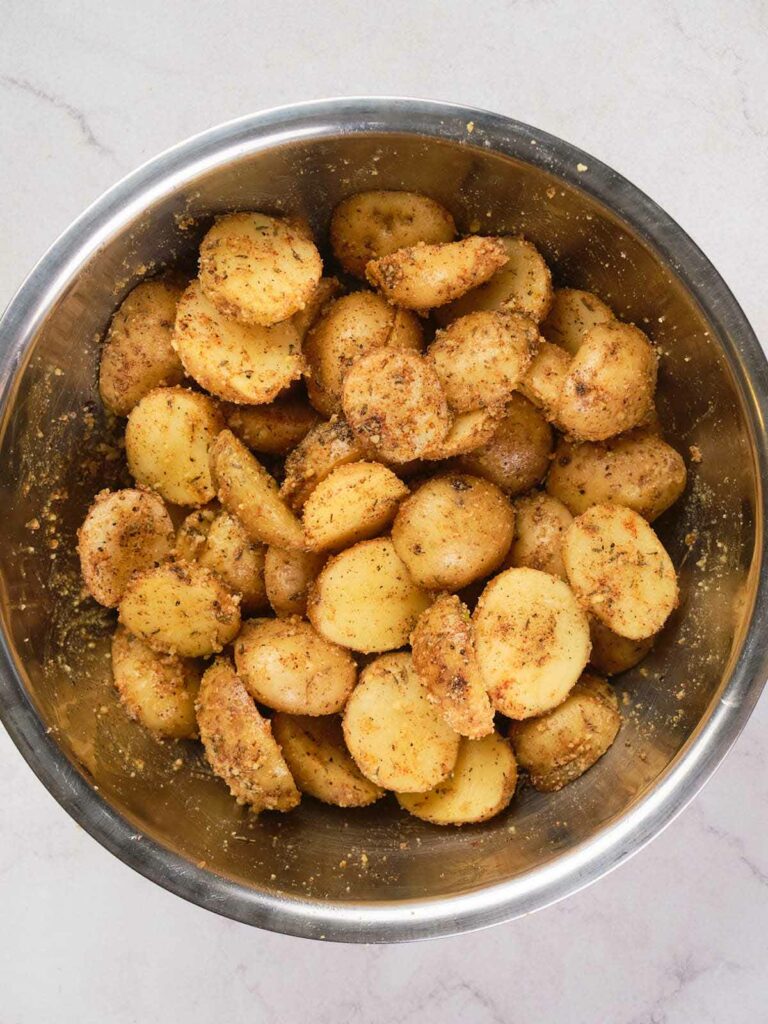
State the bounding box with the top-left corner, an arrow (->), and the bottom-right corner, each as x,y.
411,594 -> 494,738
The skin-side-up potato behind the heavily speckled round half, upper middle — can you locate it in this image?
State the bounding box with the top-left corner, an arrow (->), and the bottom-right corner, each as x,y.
304,292 -> 422,417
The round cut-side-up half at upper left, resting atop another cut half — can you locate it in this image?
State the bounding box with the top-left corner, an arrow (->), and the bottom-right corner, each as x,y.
200,213 -> 323,327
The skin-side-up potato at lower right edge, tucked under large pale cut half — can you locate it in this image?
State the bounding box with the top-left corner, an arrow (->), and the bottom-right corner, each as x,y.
509,675 -> 622,793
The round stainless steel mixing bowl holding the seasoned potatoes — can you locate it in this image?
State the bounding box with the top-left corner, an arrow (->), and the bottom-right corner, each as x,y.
0,99 -> 768,942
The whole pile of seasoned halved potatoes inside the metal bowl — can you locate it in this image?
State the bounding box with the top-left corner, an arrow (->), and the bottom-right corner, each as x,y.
79,191 -> 686,824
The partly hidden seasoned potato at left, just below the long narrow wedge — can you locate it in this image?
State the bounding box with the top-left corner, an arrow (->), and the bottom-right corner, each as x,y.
176,509 -> 269,612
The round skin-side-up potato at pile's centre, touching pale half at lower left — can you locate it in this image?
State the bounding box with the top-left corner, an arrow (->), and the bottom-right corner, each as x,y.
392,473 -> 515,591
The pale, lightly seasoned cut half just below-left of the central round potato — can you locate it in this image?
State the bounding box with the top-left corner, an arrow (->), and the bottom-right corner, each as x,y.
307,538 -> 432,653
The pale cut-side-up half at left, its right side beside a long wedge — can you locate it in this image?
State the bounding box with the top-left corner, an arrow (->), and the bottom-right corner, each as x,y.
125,387 -> 224,505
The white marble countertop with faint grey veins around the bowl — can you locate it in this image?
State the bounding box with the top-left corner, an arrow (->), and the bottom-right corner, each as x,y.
0,0 -> 768,1024
